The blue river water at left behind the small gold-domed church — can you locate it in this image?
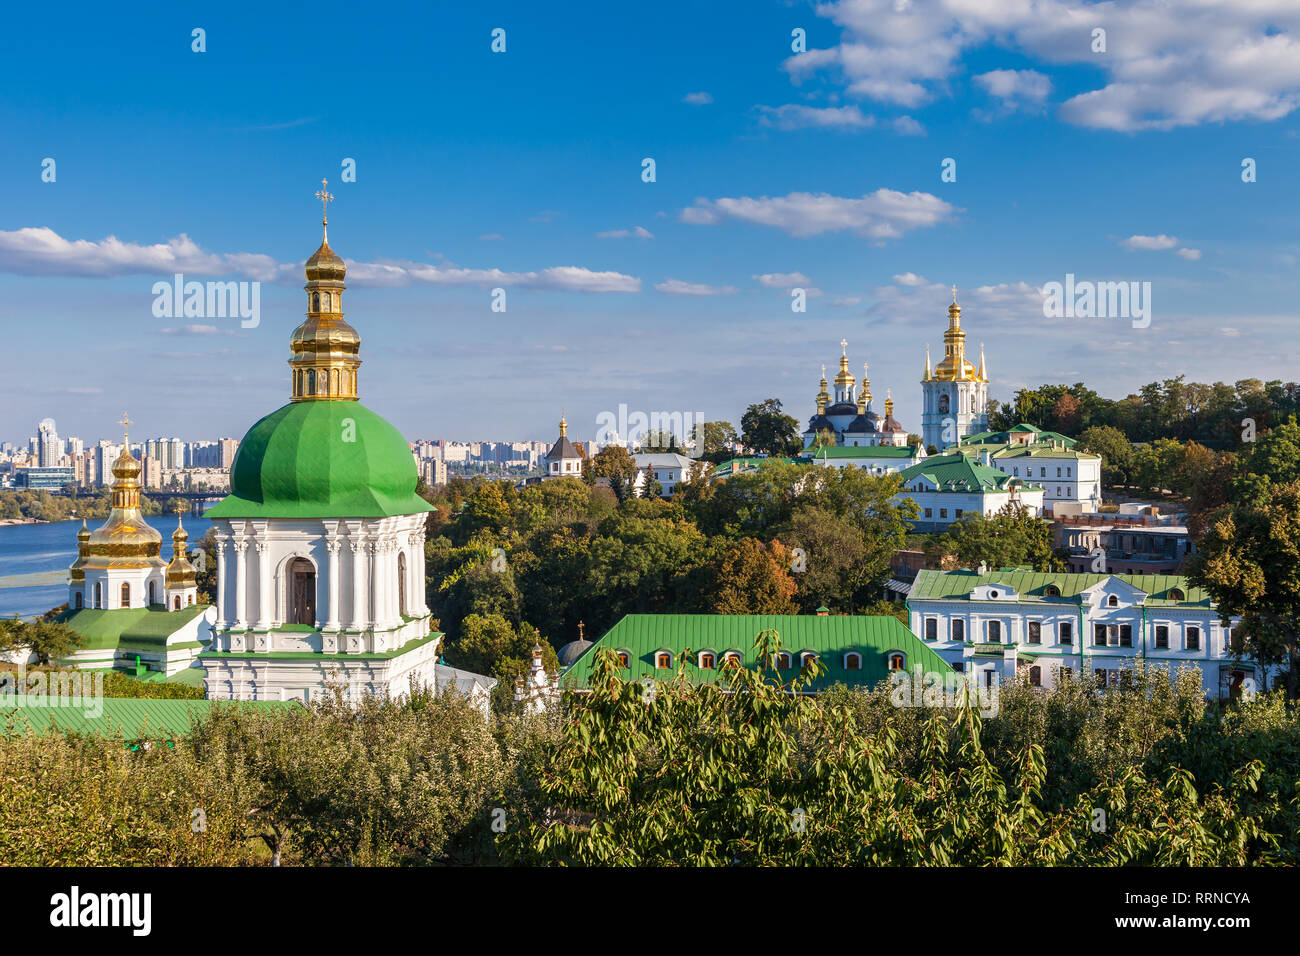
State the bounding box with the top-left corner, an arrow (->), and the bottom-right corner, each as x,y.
0,515 -> 209,618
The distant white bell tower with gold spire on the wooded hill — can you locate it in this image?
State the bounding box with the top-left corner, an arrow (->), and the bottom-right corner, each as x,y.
920,286 -> 988,451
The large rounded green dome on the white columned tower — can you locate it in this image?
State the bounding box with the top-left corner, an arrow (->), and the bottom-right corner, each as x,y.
207,402 -> 434,518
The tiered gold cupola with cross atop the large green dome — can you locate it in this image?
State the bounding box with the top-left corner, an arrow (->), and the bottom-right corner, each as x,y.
289,179 -> 361,402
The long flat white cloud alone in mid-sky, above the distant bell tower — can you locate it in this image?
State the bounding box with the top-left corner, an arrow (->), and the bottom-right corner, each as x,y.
681,189 -> 956,239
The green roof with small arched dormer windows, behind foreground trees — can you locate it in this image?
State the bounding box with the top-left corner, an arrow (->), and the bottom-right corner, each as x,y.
562,614 -> 953,691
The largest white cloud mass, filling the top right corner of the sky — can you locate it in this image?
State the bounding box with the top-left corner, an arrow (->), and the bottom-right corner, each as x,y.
784,0 -> 1300,131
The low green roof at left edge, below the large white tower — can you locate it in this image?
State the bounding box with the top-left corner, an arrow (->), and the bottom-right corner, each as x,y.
0,697 -> 298,740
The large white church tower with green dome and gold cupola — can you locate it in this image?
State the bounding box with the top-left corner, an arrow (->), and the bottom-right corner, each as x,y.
199,184 -> 442,701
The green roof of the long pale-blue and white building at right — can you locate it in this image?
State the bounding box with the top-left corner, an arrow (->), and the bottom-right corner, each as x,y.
907,571 -> 1210,607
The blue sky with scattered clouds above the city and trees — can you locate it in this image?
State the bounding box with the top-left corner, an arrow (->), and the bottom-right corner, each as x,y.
0,0 -> 1300,441
